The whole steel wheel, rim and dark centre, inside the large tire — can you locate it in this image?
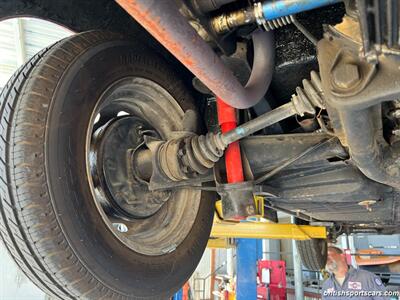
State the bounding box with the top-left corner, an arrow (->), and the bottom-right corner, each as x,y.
85,77 -> 202,256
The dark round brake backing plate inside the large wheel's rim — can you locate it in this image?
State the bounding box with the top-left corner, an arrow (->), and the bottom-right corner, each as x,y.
94,116 -> 171,218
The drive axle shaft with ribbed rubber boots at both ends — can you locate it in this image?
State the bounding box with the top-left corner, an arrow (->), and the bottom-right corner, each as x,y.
134,86 -> 319,181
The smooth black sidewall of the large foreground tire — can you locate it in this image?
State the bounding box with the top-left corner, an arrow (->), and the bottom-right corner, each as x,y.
45,40 -> 213,299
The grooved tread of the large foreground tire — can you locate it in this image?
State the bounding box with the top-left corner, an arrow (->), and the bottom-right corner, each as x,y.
0,31 -> 132,299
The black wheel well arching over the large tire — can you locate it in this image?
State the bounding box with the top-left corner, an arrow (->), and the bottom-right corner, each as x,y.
0,0 -> 201,109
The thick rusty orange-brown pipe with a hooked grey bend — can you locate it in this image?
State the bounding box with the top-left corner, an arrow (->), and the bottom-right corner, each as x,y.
116,0 -> 275,109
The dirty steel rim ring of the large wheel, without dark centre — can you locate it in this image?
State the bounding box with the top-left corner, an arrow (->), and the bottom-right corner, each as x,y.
86,77 -> 201,256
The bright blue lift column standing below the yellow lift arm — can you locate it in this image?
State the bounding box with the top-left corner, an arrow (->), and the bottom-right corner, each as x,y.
236,239 -> 258,300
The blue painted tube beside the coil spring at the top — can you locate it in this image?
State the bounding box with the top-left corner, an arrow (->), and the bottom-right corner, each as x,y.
262,0 -> 342,20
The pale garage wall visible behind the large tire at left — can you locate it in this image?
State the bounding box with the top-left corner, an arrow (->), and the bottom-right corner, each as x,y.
0,18 -> 72,300
